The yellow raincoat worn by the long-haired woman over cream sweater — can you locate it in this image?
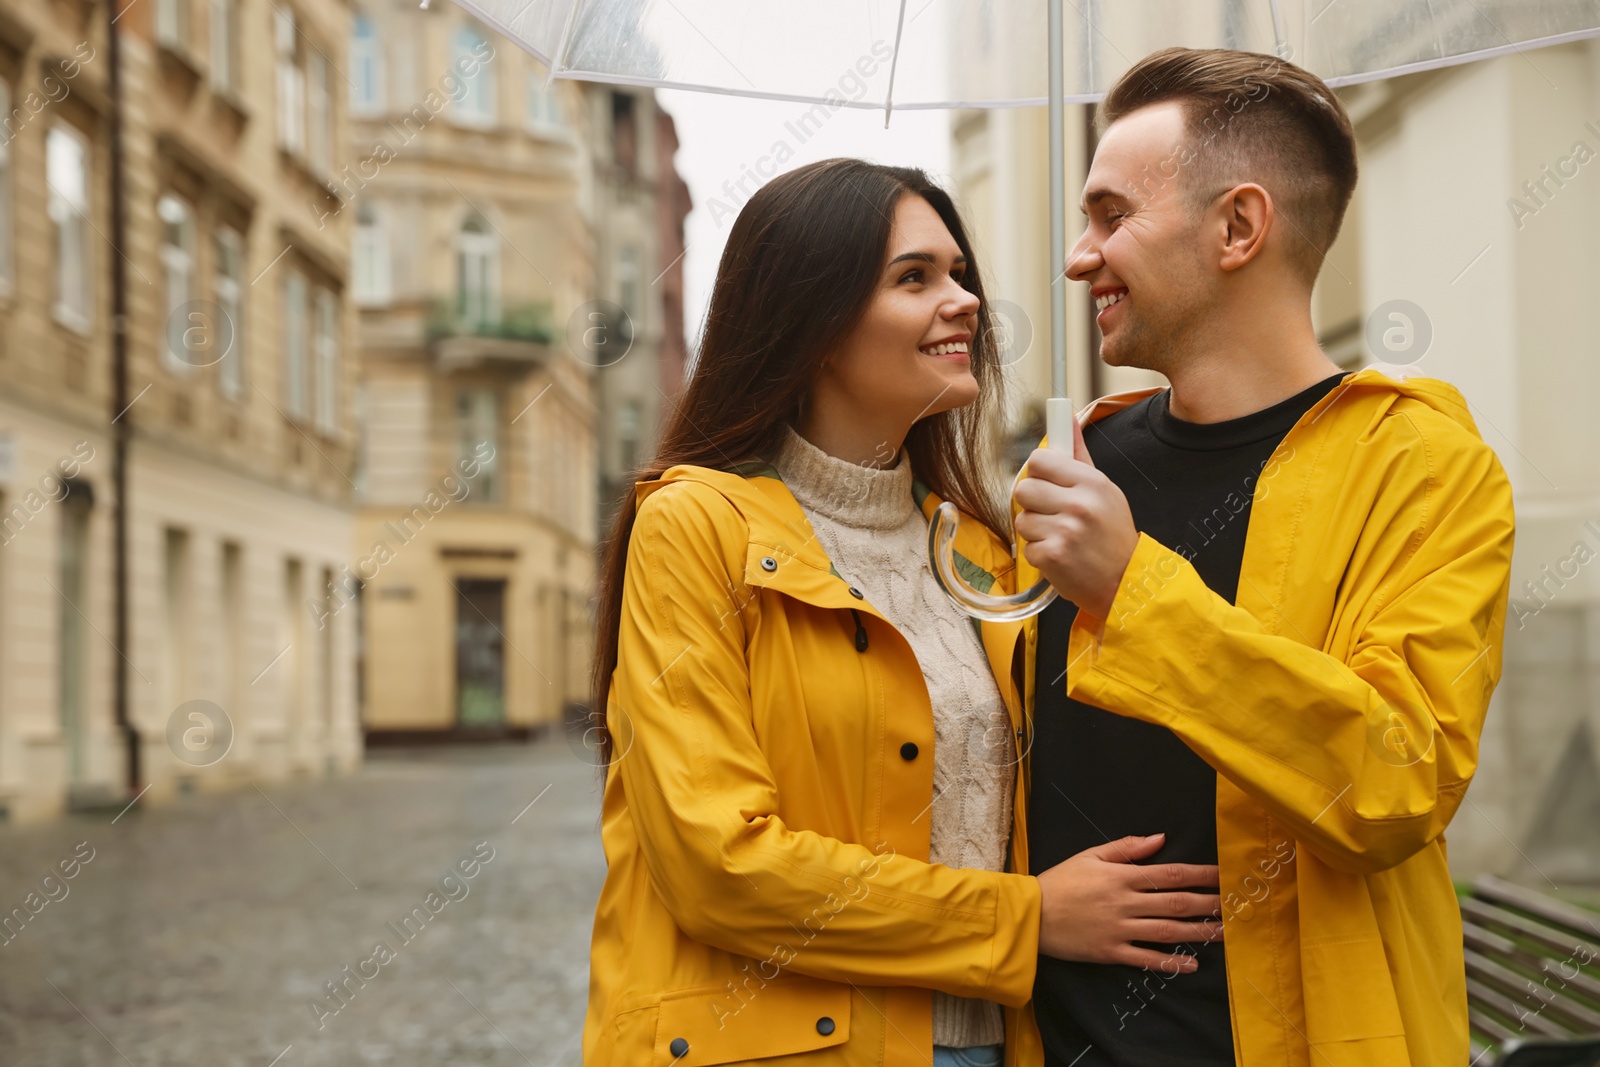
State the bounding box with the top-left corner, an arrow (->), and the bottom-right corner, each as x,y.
582,466 -> 1043,1067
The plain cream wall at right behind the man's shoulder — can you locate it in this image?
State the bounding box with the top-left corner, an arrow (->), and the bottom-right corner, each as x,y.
1355,42 -> 1600,885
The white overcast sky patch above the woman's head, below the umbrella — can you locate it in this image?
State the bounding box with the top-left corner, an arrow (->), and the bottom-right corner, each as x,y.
656,90 -> 950,355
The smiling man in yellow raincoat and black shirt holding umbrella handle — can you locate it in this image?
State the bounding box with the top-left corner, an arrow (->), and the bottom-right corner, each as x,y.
1016,48 -> 1514,1067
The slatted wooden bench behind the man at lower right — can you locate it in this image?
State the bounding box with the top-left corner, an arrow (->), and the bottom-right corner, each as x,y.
1461,875 -> 1600,1067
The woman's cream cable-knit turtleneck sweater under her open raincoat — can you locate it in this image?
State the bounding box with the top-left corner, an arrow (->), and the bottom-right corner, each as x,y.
773,429 -> 1016,1048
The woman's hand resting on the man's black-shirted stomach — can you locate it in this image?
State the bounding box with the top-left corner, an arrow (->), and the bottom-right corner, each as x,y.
1038,833 -> 1222,974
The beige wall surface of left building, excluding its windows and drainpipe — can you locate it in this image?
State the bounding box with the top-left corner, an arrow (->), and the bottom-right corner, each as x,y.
0,0 -> 360,819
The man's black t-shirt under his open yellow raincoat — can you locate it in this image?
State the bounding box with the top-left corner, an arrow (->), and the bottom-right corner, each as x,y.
1027,373 -> 1344,1067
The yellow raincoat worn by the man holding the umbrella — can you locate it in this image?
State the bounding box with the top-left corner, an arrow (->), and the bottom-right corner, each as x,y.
1018,370 -> 1514,1067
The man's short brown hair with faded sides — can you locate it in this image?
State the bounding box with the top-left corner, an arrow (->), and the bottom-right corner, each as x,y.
1098,48 -> 1357,286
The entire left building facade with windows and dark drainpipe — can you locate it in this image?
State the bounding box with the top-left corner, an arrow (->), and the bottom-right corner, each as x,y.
0,0 -> 360,819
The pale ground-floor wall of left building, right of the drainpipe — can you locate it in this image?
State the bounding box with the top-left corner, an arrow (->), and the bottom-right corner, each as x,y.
130,450 -> 360,777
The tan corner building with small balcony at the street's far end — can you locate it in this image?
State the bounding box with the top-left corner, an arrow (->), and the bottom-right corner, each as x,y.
341,3 -> 688,741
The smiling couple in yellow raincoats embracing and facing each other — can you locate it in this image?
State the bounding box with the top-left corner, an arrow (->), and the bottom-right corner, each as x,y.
584,50 -> 1512,1067
